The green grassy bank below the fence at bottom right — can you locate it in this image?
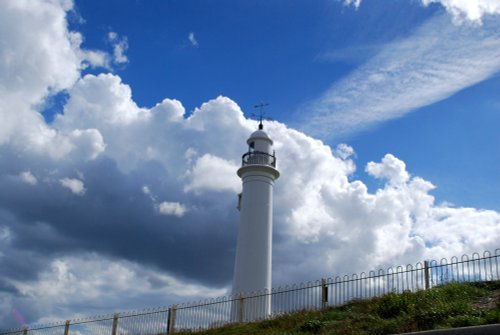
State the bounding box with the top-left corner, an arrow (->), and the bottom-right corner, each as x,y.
176,282 -> 500,335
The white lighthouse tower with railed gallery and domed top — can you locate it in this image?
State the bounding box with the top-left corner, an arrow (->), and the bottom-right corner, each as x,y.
233,114 -> 280,321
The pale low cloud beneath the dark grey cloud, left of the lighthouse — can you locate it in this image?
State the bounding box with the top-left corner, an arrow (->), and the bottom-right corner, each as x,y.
10,254 -> 226,323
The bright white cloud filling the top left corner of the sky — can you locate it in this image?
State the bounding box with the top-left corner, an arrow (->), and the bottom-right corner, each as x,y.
0,0 -> 109,163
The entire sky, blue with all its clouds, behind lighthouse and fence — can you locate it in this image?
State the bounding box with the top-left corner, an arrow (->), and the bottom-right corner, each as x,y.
0,0 -> 500,329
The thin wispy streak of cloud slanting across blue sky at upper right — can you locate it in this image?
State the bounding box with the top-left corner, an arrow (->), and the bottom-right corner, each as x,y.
302,15 -> 500,138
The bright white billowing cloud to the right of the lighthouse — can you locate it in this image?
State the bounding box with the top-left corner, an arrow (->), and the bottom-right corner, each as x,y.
273,138 -> 500,283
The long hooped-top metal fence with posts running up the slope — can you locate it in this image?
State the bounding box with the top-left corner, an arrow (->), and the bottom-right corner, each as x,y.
0,249 -> 500,335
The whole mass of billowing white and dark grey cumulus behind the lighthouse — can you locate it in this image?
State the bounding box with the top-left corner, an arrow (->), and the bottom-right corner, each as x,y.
0,1 -> 500,326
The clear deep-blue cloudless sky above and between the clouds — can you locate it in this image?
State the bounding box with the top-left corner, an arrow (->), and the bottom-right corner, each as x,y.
70,1 -> 500,210
